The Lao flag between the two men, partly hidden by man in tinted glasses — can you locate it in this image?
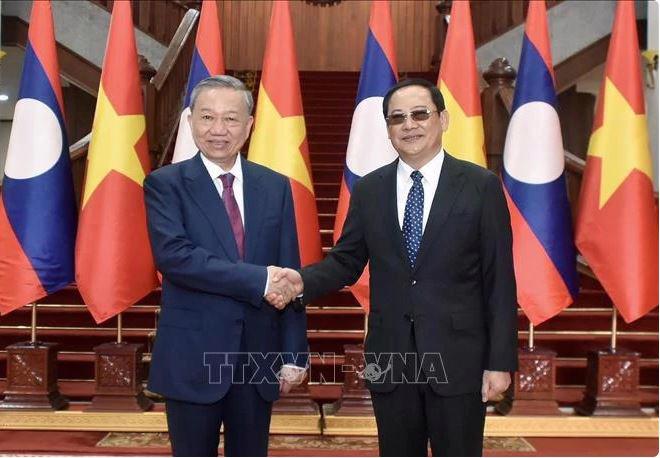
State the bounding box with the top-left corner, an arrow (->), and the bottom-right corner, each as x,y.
333,1 -> 397,310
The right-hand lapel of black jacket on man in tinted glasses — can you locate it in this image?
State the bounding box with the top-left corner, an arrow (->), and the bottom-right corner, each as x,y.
413,153 -> 465,272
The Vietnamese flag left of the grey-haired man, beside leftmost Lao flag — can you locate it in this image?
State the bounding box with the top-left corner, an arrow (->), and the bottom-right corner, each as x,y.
76,0 -> 157,323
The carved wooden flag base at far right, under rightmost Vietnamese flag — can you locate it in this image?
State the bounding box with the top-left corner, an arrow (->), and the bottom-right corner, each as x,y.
575,348 -> 646,417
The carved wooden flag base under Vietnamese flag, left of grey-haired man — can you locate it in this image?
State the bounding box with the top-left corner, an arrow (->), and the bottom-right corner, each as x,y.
85,343 -> 153,412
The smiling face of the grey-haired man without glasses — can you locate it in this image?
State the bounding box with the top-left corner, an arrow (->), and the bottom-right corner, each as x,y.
188,87 -> 254,170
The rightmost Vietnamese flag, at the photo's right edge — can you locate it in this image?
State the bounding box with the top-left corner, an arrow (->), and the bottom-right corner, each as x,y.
576,1 -> 658,323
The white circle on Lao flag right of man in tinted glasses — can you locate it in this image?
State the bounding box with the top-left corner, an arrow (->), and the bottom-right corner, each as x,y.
504,102 -> 564,184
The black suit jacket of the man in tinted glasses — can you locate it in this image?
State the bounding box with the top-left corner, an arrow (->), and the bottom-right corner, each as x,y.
301,154 -> 517,395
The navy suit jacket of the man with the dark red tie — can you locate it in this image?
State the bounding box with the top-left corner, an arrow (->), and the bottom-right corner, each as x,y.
144,153 -> 307,403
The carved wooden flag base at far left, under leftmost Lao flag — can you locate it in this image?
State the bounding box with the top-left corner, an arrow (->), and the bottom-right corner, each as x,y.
0,342 -> 69,410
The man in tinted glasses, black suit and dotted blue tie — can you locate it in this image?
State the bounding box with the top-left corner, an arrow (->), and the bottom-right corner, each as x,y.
269,79 -> 517,456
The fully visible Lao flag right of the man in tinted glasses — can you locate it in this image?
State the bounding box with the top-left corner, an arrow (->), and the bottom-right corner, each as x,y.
502,1 -> 578,325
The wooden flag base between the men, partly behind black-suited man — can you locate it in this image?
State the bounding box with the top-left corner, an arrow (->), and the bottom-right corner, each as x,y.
329,345 -> 374,417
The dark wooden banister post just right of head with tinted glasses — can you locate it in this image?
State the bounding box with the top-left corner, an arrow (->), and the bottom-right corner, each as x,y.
481,57 -> 516,173
